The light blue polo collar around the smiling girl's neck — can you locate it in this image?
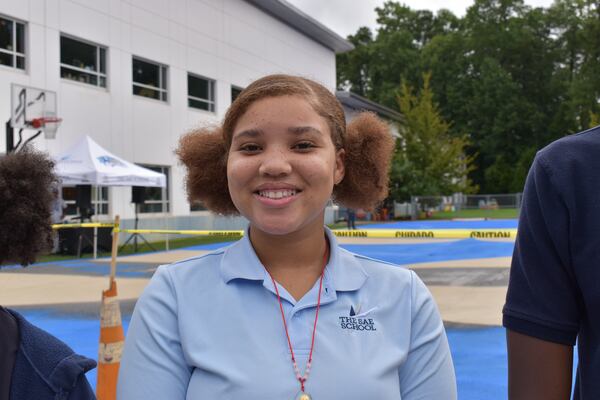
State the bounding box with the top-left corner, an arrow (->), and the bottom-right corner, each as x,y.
221,227 -> 368,291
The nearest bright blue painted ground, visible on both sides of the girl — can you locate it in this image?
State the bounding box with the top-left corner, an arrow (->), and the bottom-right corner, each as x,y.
22,310 -> 507,400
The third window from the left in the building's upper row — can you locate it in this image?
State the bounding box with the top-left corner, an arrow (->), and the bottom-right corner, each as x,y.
133,57 -> 167,101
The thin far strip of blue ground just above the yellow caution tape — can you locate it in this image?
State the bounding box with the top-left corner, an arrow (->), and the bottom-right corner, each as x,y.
361,219 -> 518,229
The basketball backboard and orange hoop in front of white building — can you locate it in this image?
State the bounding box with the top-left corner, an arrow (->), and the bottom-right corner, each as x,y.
10,83 -> 61,138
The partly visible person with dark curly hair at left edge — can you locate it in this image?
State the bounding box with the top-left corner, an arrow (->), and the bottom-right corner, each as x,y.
0,148 -> 96,400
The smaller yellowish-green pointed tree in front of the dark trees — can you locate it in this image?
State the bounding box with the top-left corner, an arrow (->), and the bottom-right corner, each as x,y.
391,73 -> 476,201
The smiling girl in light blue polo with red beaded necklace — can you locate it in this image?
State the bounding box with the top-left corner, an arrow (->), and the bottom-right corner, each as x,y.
118,75 -> 456,400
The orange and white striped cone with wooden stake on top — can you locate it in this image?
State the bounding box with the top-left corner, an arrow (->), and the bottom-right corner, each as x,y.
96,215 -> 125,400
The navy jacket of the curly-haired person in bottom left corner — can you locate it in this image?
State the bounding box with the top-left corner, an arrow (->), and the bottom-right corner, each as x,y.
8,310 -> 96,400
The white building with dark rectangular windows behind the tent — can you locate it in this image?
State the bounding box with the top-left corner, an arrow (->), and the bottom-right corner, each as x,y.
0,0 -> 352,229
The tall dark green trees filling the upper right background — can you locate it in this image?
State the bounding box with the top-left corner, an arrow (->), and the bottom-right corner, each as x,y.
338,0 -> 600,193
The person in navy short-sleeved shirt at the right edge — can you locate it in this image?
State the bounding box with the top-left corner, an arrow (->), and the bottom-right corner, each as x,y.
503,127 -> 600,400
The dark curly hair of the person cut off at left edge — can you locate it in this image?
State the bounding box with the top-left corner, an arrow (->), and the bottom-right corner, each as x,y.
0,147 -> 58,265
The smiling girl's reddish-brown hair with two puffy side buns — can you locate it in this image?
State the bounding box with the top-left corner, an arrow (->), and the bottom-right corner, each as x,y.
176,75 -> 394,215
